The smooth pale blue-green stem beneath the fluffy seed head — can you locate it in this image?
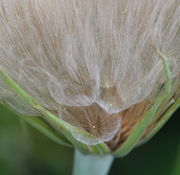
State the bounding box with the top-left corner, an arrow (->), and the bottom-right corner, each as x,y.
73,150 -> 114,175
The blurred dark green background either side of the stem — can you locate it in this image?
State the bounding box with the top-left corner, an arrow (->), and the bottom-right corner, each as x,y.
0,106 -> 180,175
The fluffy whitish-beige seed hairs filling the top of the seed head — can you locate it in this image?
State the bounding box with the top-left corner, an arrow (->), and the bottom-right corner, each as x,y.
0,0 -> 180,144
